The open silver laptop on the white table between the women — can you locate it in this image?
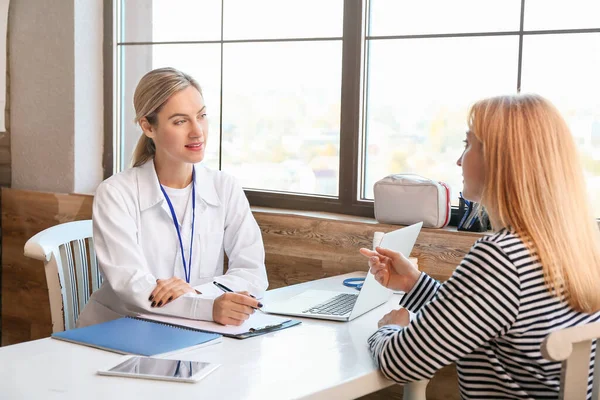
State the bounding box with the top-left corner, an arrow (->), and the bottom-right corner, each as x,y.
263,222 -> 423,321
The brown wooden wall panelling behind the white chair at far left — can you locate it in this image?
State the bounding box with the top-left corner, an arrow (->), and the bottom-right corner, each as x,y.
1,188 -> 93,346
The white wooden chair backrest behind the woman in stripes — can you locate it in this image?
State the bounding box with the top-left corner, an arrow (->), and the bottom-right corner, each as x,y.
541,322 -> 600,400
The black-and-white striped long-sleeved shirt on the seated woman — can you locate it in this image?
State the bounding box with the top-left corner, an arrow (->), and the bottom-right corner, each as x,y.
369,229 -> 600,399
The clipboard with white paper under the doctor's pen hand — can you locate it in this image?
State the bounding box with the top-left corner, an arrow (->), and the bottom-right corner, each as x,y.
137,312 -> 300,339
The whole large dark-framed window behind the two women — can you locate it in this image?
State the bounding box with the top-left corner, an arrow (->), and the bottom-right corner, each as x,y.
110,0 -> 600,217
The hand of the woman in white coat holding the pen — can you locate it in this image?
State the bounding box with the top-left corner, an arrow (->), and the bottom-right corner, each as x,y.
213,292 -> 262,326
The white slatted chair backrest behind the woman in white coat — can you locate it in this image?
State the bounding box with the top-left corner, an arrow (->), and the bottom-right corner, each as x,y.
24,220 -> 102,332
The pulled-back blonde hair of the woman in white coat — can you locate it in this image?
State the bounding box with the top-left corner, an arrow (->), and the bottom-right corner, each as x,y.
131,68 -> 202,167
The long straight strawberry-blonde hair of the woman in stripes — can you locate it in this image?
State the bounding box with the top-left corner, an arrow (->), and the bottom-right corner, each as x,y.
469,95 -> 600,313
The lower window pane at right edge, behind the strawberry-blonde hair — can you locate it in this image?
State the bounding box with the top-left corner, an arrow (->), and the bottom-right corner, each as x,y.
522,33 -> 600,217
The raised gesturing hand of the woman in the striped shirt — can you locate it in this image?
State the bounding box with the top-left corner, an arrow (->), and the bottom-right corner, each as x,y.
360,247 -> 421,292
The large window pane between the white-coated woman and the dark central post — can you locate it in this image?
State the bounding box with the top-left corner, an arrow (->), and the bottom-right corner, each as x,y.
222,40 -> 342,196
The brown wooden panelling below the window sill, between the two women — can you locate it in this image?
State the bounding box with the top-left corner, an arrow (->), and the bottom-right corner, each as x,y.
254,212 -> 481,288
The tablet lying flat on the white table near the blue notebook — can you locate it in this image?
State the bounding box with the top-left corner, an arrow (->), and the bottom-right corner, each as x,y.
98,356 -> 220,383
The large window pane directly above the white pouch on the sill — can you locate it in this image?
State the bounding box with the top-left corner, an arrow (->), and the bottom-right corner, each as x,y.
363,36 -> 519,205
